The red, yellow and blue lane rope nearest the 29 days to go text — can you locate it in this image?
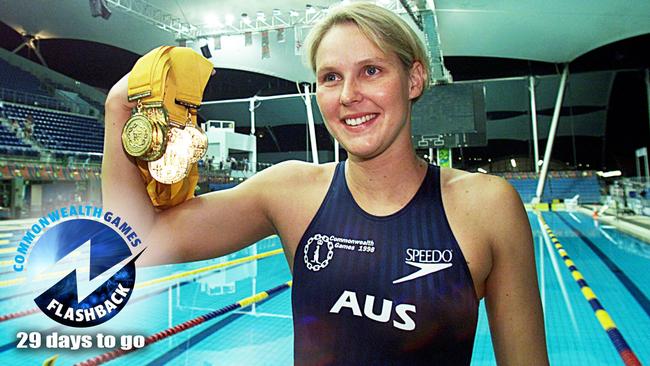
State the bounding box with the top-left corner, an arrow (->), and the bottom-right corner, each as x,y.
71,280 -> 293,366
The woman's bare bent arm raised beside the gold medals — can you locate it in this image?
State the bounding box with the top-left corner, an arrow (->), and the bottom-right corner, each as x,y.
102,75 -> 281,264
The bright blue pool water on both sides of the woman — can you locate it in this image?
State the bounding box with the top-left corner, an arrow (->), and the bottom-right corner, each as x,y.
0,212 -> 650,366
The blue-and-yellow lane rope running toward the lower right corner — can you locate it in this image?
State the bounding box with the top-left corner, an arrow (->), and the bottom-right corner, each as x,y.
538,213 -> 641,366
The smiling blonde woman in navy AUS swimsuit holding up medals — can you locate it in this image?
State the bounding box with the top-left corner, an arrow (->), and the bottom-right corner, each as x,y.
103,3 -> 548,365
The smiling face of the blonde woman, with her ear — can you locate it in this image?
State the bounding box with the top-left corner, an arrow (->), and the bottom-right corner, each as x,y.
315,23 -> 423,159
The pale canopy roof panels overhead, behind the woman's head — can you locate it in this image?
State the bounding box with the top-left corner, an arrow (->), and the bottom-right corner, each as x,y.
0,0 -> 650,64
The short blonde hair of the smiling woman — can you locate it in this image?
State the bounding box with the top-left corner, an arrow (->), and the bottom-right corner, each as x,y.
305,2 -> 429,86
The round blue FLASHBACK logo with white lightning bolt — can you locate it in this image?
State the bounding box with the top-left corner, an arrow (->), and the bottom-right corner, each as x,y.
20,208 -> 142,327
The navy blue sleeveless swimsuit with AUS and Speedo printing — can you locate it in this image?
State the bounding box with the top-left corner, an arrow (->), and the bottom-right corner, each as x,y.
292,162 -> 478,365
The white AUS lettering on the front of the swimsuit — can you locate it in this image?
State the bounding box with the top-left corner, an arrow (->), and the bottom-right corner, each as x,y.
330,290 -> 415,330
